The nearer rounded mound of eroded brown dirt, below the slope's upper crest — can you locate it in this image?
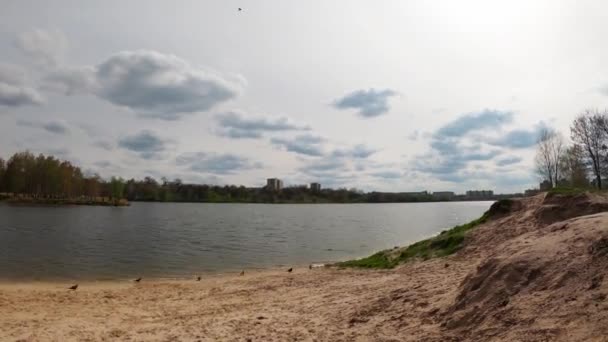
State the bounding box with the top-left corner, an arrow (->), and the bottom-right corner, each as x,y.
442,213 -> 608,341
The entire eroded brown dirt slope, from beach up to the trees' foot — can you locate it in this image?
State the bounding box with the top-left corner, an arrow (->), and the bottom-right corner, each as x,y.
344,194 -> 608,341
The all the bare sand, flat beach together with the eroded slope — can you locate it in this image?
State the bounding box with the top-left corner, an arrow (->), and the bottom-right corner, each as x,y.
0,195 -> 608,341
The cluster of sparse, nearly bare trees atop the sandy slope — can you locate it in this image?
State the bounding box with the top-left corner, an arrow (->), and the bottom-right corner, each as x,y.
535,110 -> 608,189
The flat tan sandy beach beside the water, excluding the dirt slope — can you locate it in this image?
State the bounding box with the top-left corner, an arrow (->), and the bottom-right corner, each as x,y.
0,260 -> 468,341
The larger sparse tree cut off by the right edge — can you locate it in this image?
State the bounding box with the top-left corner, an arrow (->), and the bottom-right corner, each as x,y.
570,110 -> 608,189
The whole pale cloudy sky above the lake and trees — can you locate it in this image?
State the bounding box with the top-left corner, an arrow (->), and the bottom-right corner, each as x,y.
0,0 -> 608,192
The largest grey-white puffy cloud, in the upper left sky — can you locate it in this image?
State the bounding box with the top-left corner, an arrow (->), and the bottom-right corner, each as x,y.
96,50 -> 242,120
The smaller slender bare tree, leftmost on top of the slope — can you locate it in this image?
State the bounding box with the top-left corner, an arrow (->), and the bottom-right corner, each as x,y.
536,128 -> 564,187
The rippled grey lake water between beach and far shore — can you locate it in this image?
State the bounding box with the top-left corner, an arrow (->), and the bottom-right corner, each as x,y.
0,202 -> 491,280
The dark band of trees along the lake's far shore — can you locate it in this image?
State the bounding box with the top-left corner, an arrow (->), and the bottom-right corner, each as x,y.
0,151 -> 446,203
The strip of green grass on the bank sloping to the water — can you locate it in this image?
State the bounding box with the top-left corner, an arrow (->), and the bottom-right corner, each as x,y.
336,199 -> 513,268
